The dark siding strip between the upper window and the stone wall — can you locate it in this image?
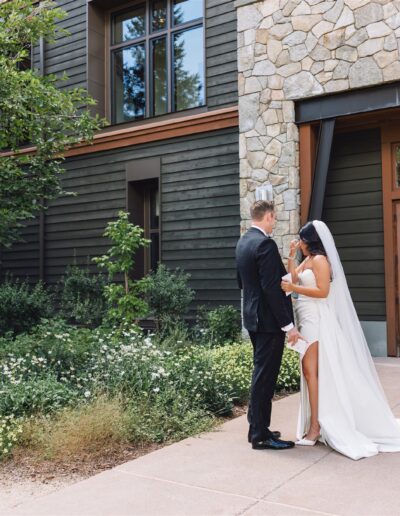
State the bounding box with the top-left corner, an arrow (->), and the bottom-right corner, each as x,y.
205,0 -> 238,108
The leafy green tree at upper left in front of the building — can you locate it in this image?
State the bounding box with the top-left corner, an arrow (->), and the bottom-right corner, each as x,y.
0,0 -> 105,245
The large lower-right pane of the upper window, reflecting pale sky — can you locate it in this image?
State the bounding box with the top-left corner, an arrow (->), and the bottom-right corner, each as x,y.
173,27 -> 204,111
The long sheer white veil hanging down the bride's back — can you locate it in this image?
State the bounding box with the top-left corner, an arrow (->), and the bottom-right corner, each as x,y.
313,220 -> 387,403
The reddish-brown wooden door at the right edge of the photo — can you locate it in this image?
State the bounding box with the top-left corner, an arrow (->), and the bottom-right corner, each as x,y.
382,126 -> 400,356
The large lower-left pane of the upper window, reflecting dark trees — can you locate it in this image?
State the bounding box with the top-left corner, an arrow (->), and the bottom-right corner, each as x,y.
113,45 -> 145,123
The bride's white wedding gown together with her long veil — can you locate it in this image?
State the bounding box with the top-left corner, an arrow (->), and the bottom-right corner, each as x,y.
295,221 -> 400,460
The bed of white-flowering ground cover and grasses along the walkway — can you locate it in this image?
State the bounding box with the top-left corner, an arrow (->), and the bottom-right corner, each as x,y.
0,319 -> 299,464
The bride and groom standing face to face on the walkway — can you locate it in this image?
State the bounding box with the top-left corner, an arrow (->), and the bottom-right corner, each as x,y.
236,201 -> 400,460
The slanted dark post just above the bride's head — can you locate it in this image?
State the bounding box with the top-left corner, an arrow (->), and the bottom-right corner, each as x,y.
309,118 -> 335,220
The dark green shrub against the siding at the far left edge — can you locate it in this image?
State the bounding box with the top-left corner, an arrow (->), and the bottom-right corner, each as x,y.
0,277 -> 53,335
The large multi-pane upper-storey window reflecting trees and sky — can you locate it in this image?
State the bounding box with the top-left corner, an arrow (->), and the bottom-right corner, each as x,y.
110,0 -> 205,123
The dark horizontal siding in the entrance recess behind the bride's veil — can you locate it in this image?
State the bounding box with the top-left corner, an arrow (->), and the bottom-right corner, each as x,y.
323,129 -> 386,321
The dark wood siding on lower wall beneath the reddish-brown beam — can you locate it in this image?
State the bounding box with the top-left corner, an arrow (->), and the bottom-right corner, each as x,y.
3,128 -> 240,306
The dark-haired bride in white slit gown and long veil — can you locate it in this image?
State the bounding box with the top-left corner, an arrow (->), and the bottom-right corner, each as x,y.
282,220 -> 400,460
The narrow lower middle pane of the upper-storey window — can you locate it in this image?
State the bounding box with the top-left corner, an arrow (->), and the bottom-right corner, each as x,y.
152,38 -> 168,116
